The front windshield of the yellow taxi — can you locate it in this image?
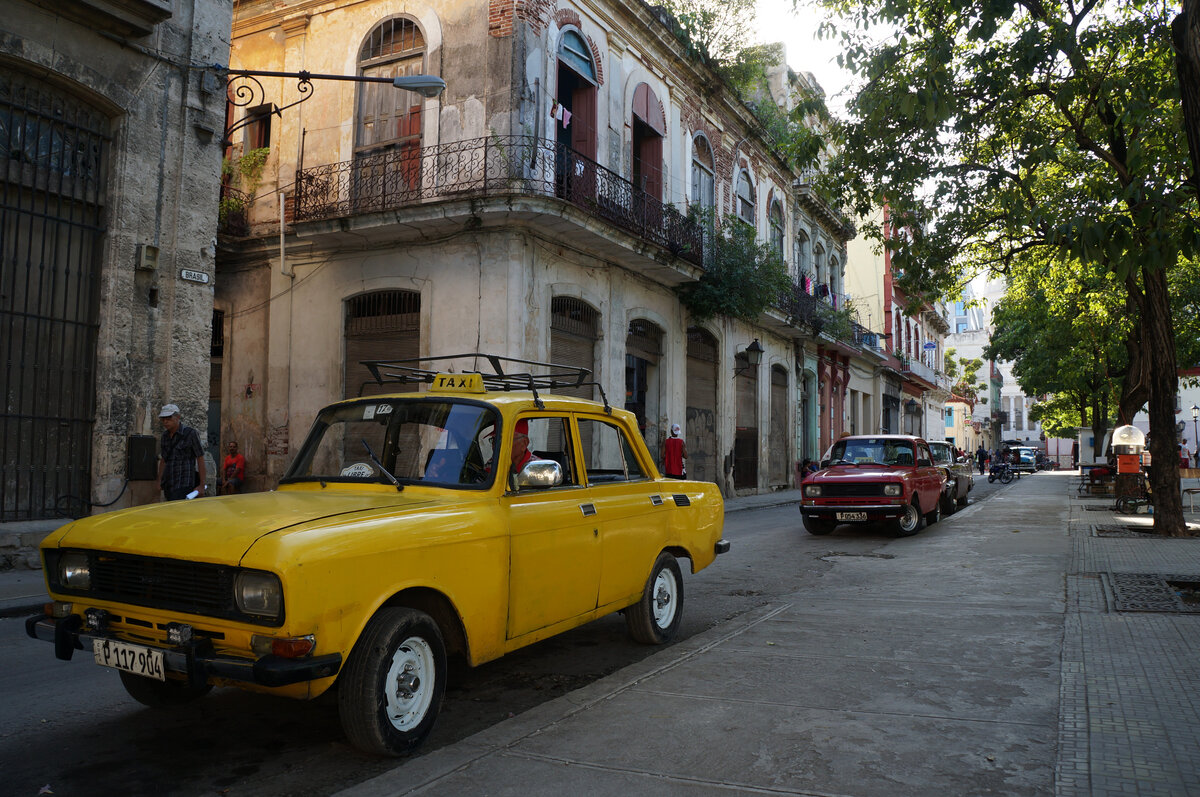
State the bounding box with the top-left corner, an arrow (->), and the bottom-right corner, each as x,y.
280,399 -> 499,489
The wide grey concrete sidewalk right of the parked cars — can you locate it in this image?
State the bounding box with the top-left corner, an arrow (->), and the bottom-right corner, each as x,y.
342,473 -> 1200,797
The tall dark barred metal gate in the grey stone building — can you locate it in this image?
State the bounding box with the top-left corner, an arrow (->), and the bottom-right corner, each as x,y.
0,66 -> 109,521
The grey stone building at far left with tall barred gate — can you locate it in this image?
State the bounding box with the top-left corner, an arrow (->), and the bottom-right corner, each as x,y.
0,0 -> 232,554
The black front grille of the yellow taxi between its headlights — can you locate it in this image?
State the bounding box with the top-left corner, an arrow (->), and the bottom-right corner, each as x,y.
46,551 -> 277,625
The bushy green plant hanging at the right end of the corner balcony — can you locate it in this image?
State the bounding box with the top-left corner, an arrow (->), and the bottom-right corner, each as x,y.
677,215 -> 792,323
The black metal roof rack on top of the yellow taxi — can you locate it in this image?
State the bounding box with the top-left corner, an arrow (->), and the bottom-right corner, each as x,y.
359,352 -> 612,415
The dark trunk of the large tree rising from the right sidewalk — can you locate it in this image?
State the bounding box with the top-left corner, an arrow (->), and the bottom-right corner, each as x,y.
1141,268 -> 1188,537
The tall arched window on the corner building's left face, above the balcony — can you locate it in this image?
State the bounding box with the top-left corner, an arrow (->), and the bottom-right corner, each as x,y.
355,17 -> 425,154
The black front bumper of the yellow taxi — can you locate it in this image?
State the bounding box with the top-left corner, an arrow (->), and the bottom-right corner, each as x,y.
25,615 -> 342,687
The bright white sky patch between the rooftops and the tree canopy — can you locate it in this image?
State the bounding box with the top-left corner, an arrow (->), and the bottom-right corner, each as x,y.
757,0 -> 852,113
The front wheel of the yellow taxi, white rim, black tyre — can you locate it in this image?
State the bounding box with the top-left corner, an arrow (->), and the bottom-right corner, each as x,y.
337,607 -> 446,755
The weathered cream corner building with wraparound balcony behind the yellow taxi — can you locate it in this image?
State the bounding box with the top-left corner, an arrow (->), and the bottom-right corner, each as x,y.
212,0 -> 865,495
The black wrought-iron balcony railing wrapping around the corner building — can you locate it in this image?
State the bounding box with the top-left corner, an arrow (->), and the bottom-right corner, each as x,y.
294,136 -> 704,266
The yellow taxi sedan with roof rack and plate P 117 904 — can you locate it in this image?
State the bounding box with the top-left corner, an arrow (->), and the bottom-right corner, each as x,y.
26,355 -> 728,755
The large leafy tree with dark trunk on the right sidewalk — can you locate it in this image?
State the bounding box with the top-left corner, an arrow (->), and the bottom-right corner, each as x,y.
821,0 -> 1200,534
